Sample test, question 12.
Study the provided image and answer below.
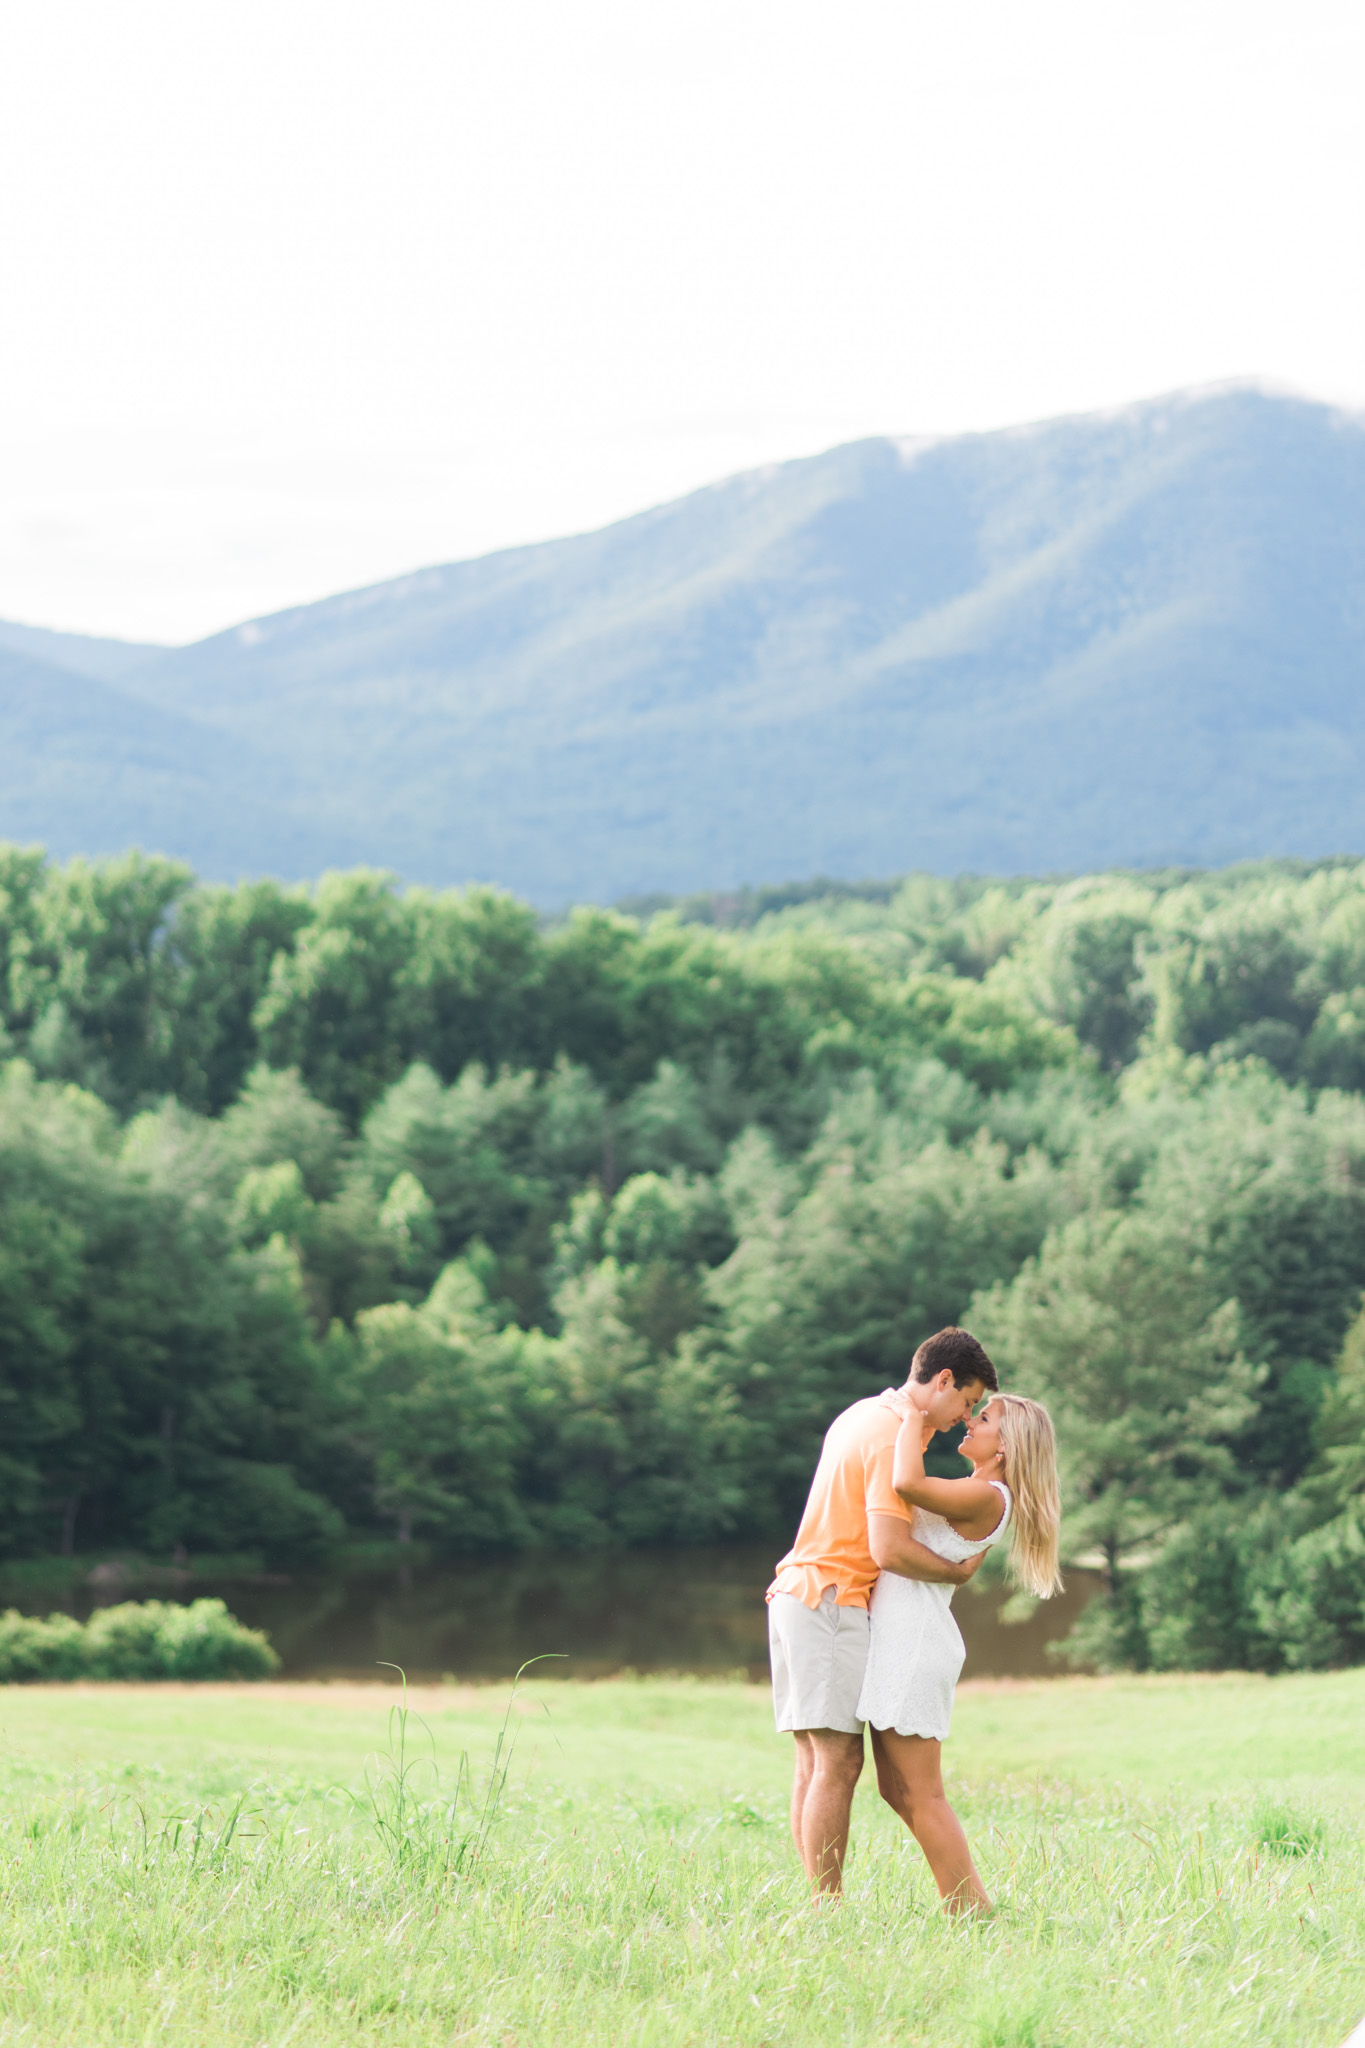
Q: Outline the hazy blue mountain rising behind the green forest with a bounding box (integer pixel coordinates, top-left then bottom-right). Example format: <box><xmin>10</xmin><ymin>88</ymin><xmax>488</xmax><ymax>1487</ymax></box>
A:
<box><xmin>0</xmin><ymin>391</ymin><xmax>1365</xmax><ymax>905</ymax></box>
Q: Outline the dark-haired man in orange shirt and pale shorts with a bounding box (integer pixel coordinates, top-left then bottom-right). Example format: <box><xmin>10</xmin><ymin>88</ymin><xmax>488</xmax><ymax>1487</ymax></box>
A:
<box><xmin>767</xmin><ymin>1329</ymin><xmax>999</xmax><ymax>1892</ymax></box>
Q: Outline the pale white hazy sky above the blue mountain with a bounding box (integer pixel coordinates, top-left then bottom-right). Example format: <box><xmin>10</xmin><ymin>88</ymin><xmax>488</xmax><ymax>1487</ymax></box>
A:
<box><xmin>0</xmin><ymin>0</ymin><xmax>1365</xmax><ymax>639</ymax></box>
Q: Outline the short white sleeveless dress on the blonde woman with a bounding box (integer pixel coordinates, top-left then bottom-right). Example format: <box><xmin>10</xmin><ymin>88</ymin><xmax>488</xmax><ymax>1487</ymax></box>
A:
<box><xmin>857</xmin><ymin>1479</ymin><xmax>1011</xmax><ymax>1743</ymax></box>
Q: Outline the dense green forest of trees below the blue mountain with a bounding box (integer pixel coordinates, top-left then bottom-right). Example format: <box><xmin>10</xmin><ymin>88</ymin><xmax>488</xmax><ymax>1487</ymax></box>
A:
<box><xmin>0</xmin><ymin>848</ymin><xmax>1365</xmax><ymax>1669</ymax></box>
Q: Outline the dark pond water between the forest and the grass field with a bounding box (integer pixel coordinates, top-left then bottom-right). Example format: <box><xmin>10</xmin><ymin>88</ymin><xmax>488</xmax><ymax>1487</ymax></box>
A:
<box><xmin>82</xmin><ymin>1542</ymin><xmax>1095</xmax><ymax>1679</ymax></box>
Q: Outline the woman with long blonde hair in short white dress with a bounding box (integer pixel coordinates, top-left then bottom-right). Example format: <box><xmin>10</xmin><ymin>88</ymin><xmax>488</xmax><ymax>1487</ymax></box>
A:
<box><xmin>857</xmin><ymin>1395</ymin><xmax>1062</xmax><ymax>1913</ymax></box>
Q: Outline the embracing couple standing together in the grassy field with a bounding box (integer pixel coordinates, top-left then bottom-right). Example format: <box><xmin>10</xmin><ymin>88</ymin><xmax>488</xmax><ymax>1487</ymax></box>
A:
<box><xmin>767</xmin><ymin>1329</ymin><xmax>1062</xmax><ymax>1913</ymax></box>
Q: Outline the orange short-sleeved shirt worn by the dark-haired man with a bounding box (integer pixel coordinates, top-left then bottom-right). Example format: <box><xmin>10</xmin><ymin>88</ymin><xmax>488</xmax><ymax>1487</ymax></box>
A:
<box><xmin>767</xmin><ymin>1386</ymin><xmax>915</xmax><ymax>1608</ymax></box>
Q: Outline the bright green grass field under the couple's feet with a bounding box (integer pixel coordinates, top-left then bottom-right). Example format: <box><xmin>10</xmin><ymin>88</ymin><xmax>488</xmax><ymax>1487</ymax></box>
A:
<box><xmin>0</xmin><ymin>1671</ymin><xmax>1365</xmax><ymax>2048</ymax></box>
